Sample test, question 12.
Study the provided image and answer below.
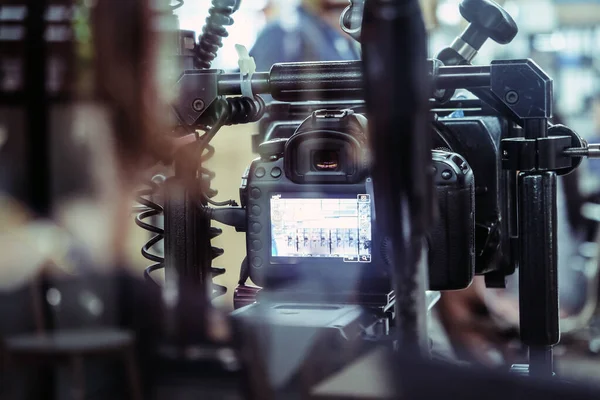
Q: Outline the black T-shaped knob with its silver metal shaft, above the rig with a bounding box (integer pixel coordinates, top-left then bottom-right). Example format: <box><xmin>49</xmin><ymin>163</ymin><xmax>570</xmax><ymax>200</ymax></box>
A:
<box><xmin>436</xmin><ymin>0</ymin><xmax>519</xmax><ymax>65</ymax></box>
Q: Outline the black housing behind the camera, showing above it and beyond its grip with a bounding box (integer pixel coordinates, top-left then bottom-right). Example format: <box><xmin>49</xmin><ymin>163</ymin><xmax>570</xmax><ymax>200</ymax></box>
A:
<box><xmin>253</xmin><ymin>101</ymin><xmax>519</xmax><ymax>287</ymax></box>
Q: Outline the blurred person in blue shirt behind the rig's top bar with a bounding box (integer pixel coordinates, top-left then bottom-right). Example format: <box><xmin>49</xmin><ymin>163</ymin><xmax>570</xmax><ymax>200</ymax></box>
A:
<box><xmin>250</xmin><ymin>0</ymin><xmax>360</xmax><ymax>71</ymax></box>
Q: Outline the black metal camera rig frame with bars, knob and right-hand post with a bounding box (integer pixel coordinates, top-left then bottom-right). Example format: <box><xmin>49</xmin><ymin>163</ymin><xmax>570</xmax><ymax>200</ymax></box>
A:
<box><xmin>138</xmin><ymin>0</ymin><xmax>597</xmax><ymax>382</ymax></box>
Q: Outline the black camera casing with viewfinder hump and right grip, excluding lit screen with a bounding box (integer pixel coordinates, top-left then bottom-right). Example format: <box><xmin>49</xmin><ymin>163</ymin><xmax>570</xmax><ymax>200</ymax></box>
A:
<box><xmin>240</xmin><ymin>104</ymin><xmax>486</xmax><ymax>298</ymax></box>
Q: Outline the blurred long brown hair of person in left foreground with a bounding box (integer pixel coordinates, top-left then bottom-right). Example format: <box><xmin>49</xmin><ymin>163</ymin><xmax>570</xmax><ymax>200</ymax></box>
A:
<box><xmin>92</xmin><ymin>0</ymin><xmax>169</xmax><ymax>183</ymax></box>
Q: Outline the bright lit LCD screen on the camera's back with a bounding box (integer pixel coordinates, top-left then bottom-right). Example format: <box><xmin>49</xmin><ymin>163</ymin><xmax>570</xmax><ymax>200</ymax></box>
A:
<box><xmin>271</xmin><ymin>194</ymin><xmax>371</xmax><ymax>262</ymax></box>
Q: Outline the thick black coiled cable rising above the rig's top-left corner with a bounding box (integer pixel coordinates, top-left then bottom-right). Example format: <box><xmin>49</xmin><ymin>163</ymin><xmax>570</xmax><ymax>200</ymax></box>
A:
<box><xmin>195</xmin><ymin>0</ymin><xmax>238</xmax><ymax>69</ymax></box>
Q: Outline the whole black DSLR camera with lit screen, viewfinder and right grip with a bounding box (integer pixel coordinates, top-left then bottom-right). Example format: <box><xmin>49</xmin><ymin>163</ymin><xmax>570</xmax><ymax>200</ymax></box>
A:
<box><xmin>241</xmin><ymin>104</ymin><xmax>476</xmax><ymax>305</ymax></box>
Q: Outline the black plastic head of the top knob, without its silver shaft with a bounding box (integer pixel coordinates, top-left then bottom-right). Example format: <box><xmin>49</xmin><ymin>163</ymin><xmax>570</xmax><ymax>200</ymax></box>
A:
<box><xmin>459</xmin><ymin>0</ymin><xmax>519</xmax><ymax>46</ymax></box>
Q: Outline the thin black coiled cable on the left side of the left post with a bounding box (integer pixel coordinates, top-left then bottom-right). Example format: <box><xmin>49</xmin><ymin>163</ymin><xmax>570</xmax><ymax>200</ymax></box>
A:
<box><xmin>135</xmin><ymin>181</ymin><xmax>165</xmax><ymax>283</ymax></box>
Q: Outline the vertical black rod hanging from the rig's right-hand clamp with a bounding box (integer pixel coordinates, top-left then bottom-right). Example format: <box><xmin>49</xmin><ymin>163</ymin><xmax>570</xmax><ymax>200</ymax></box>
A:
<box><xmin>518</xmin><ymin>172</ymin><xmax>560</xmax><ymax>377</ymax></box>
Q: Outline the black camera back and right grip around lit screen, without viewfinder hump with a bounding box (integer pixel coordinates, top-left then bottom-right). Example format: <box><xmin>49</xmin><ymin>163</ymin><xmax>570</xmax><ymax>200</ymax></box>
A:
<box><xmin>241</xmin><ymin>145</ymin><xmax>475</xmax><ymax>294</ymax></box>
